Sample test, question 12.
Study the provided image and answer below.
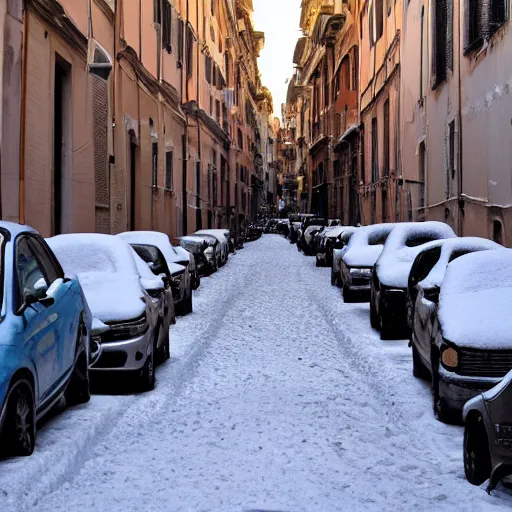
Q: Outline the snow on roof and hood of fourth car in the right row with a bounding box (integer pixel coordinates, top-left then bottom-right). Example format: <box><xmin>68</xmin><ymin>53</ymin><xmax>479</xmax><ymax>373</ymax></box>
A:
<box><xmin>343</xmin><ymin>224</ymin><xmax>396</xmax><ymax>267</ymax></box>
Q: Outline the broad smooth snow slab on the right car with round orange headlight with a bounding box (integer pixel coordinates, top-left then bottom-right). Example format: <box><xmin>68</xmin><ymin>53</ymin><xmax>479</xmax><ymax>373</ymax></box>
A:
<box><xmin>438</xmin><ymin>249</ymin><xmax>512</xmax><ymax>349</ymax></box>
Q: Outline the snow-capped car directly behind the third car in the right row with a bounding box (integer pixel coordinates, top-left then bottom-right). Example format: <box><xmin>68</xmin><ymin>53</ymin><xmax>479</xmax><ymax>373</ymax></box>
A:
<box><xmin>339</xmin><ymin>224</ymin><xmax>396</xmax><ymax>302</ymax></box>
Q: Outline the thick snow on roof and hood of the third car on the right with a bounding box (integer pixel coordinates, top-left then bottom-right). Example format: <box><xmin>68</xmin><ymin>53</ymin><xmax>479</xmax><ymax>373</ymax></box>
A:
<box><xmin>377</xmin><ymin>221</ymin><xmax>457</xmax><ymax>288</ymax></box>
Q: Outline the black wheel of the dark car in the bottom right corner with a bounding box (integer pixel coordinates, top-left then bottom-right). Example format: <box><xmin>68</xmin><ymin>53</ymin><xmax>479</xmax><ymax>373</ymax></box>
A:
<box><xmin>464</xmin><ymin>415</ymin><xmax>492</xmax><ymax>485</ymax></box>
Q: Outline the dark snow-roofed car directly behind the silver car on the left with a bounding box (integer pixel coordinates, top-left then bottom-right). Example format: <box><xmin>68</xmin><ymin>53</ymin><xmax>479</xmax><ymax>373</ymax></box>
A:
<box><xmin>117</xmin><ymin>231</ymin><xmax>193</xmax><ymax>315</ymax></box>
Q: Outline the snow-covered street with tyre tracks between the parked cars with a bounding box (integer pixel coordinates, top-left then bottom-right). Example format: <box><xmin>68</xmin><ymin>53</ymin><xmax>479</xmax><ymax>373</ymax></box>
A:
<box><xmin>0</xmin><ymin>235</ymin><xmax>512</xmax><ymax>512</ymax></box>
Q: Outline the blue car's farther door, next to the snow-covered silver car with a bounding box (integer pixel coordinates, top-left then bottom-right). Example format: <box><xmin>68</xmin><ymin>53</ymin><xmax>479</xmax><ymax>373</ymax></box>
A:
<box><xmin>30</xmin><ymin>235</ymin><xmax>78</xmax><ymax>379</ymax></box>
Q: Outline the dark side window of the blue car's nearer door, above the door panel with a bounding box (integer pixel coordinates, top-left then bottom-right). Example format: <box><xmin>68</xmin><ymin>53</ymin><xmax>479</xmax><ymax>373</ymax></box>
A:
<box><xmin>15</xmin><ymin>236</ymin><xmax>50</xmax><ymax>309</ymax></box>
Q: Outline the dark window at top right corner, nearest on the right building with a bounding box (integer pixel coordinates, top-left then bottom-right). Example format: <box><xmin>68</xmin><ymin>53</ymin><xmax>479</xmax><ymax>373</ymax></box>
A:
<box><xmin>465</xmin><ymin>0</ymin><xmax>509</xmax><ymax>53</ymax></box>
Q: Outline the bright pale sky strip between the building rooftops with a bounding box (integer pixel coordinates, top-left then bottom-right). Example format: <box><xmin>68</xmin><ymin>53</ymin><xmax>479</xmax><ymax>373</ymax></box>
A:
<box><xmin>253</xmin><ymin>0</ymin><xmax>301</xmax><ymax>118</ymax></box>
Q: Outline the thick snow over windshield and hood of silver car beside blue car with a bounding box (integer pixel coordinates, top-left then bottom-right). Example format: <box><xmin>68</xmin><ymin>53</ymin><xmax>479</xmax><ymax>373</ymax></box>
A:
<box><xmin>46</xmin><ymin>233</ymin><xmax>146</xmax><ymax>322</ymax></box>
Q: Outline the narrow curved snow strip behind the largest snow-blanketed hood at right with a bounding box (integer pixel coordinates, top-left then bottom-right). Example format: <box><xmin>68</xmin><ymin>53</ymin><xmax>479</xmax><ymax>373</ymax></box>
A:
<box><xmin>419</xmin><ymin>236</ymin><xmax>503</xmax><ymax>289</ymax></box>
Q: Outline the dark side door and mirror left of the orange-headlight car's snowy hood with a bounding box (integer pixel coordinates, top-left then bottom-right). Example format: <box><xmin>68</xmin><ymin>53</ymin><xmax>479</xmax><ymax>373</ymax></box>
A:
<box><xmin>409</xmin><ymin>247</ymin><xmax>441</xmax><ymax>361</ymax></box>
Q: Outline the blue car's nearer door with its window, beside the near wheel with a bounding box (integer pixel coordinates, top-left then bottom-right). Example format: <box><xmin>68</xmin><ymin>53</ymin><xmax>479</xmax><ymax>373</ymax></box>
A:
<box><xmin>14</xmin><ymin>235</ymin><xmax>60</xmax><ymax>405</ymax></box>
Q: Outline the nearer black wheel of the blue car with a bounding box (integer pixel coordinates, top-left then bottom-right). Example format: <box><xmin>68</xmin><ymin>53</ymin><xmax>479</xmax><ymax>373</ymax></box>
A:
<box><xmin>3</xmin><ymin>380</ymin><xmax>36</xmax><ymax>457</ymax></box>
